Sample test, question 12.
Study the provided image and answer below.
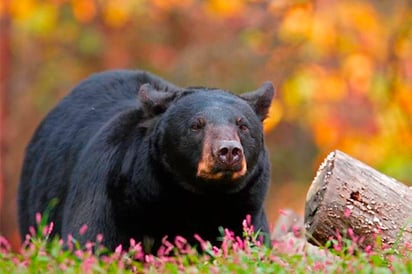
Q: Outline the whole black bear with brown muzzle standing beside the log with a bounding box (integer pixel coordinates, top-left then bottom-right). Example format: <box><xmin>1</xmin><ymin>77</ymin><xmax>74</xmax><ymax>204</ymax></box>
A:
<box><xmin>18</xmin><ymin>70</ymin><xmax>274</xmax><ymax>251</ymax></box>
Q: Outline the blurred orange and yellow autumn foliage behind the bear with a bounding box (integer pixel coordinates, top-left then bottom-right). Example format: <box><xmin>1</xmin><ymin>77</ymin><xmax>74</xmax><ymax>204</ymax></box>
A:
<box><xmin>0</xmin><ymin>0</ymin><xmax>412</xmax><ymax>249</ymax></box>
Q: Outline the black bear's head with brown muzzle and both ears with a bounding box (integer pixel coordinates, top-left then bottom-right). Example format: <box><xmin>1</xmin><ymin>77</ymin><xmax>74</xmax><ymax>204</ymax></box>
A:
<box><xmin>139</xmin><ymin>82</ymin><xmax>274</xmax><ymax>193</ymax></box>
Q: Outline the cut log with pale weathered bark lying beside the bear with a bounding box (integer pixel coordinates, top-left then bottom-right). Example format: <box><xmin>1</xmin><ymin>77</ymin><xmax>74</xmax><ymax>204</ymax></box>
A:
<box><xmin>304</xmin><ymin>151</ymin><xmax>412</xmax><ymax>248</ymax></box>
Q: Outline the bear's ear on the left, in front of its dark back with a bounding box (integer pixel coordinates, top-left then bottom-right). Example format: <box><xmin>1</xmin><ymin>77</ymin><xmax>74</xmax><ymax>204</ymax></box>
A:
<box><xmin>137</xmin><ymin>83</ymin><xmax>178</xmax><ymax>116</ymax></box>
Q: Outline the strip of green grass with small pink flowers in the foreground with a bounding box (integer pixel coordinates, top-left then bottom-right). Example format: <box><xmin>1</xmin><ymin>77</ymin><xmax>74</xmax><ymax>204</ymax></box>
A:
<box><xmin>0</xmin><ymin>216</ymin><xmax>412</xmax><ymax>274</ymax></box>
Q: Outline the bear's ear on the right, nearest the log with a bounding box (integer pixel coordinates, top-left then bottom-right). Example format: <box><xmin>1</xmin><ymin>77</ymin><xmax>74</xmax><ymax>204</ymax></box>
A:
<box><xmin>240</xmin><ymin>81</ymin><xmax>275</xmax><ymax>121</ymax></box>
